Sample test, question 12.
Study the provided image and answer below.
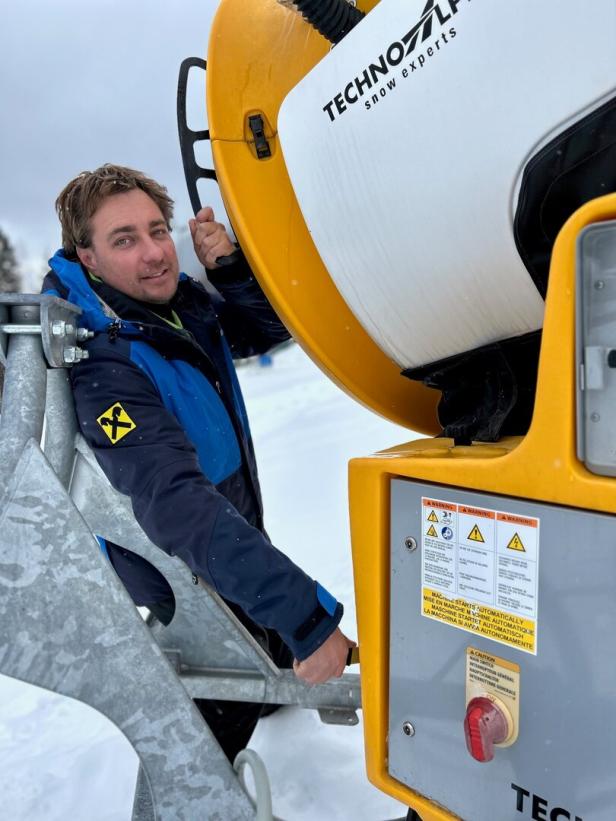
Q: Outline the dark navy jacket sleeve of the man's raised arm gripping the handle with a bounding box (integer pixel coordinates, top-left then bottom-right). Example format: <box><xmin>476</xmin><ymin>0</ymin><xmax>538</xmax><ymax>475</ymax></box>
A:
<box><xmin>207</xmin><ymin>250</ymin><xmax>290</xmax><ymax>359</ymax></box>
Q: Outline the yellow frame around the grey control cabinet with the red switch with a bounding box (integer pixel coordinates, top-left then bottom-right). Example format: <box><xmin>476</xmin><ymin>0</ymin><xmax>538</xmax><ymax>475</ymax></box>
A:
<box><xmin>349</xmin><ymin>195</ymin><xmax>616</xmax><ymax>821</ymax></box>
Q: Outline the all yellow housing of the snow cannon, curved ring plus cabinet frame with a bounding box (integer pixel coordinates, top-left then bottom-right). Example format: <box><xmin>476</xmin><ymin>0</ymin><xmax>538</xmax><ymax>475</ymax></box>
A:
<box><xmin>207</xmin><ymin>0</ymin><xmax>616</xmax><ymax>821</ymax></box>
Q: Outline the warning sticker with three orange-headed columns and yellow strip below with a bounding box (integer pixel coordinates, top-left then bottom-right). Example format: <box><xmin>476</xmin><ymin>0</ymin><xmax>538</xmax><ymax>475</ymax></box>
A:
<box><xmin>421</xmin><ymin>497</ymin><xmax>539</xmax><ymax>655</ymax></box>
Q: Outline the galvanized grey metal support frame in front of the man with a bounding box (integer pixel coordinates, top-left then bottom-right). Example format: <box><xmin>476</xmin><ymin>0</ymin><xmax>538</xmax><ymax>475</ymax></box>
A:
<box><xmin>0</xmin><ymin>294</ymin><xmax>361</xmax><ymax>821</ymax></box>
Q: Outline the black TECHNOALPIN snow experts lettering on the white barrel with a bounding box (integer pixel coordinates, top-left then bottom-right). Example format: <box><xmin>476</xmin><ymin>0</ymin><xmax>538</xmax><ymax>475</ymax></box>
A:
<box><xmin>323</xmin><ymin>0</ymin><xmax>471</xmax><ymax>122</ymax></box>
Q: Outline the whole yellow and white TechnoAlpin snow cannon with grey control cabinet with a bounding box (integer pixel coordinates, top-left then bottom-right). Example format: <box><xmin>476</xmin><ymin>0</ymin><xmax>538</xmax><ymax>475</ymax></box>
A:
<box><xmin>184</xmin><ymin>0</ymin><xmax>616</xmax><ymax>821</ymax></box>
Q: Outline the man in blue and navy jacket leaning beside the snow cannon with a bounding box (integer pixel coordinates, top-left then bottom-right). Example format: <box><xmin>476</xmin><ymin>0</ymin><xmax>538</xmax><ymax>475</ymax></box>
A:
<box><xmin>43</xmin><ymin>165</ymin><xmax>353</xmax><ymax>760</ymax></box>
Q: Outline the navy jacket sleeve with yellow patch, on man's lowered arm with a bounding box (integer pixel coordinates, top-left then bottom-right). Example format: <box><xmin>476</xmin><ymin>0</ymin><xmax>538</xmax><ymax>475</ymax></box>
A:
<box><xmin>71</xmin><ymin>339</ymin><xmax>342</xmax><ymax>660</ymax></box>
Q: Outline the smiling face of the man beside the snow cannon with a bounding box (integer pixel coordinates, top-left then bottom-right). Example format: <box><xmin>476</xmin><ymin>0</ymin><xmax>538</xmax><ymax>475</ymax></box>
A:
<box><xmin>77</xmin><ymin>188</ymin><xmax>179</xmax><ymax>304</ymax></box>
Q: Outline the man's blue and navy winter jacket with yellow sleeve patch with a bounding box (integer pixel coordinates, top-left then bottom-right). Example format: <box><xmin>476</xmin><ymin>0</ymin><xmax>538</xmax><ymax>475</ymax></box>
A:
<box><xmin>43</xmin><ymin>251</ymin><xmax>342</xmax><ymax>660</ymax></box>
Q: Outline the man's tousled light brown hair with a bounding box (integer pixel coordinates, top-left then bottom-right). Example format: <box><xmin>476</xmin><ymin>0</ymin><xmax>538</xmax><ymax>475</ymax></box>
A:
<box><xmin>56</xmin><ymin>163</ymin><xmax>173</xmax><ymax>259</ymax></box>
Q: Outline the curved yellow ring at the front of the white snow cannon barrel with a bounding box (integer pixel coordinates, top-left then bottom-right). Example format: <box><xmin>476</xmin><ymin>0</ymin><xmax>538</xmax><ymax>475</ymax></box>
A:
<box><xmin>207</xmin><ymin>0</ymin><xmax>439</xmax><ymax>433</ymax></box>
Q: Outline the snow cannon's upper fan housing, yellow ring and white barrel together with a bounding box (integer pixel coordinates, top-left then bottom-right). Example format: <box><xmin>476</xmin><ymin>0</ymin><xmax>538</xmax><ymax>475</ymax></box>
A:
<box><xmin>208</xmin><ymin>0</ymin><xmax>616</xmax><ymax>441</ymax></box>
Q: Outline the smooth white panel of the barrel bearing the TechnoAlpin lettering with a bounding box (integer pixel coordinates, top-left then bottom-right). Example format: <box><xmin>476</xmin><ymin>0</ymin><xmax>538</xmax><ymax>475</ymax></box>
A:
<box><xmin>278</xmin><ymin>0</ymin><xmax>616</xmax><ymax>367</ymax></box>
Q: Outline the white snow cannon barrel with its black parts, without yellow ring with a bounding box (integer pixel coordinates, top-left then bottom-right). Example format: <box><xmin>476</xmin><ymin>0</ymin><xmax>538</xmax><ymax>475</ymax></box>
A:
<box><xmin>278</xmin><ymin>0</ymin><xmax>616</xmax><ymax>443</ymax></box>
